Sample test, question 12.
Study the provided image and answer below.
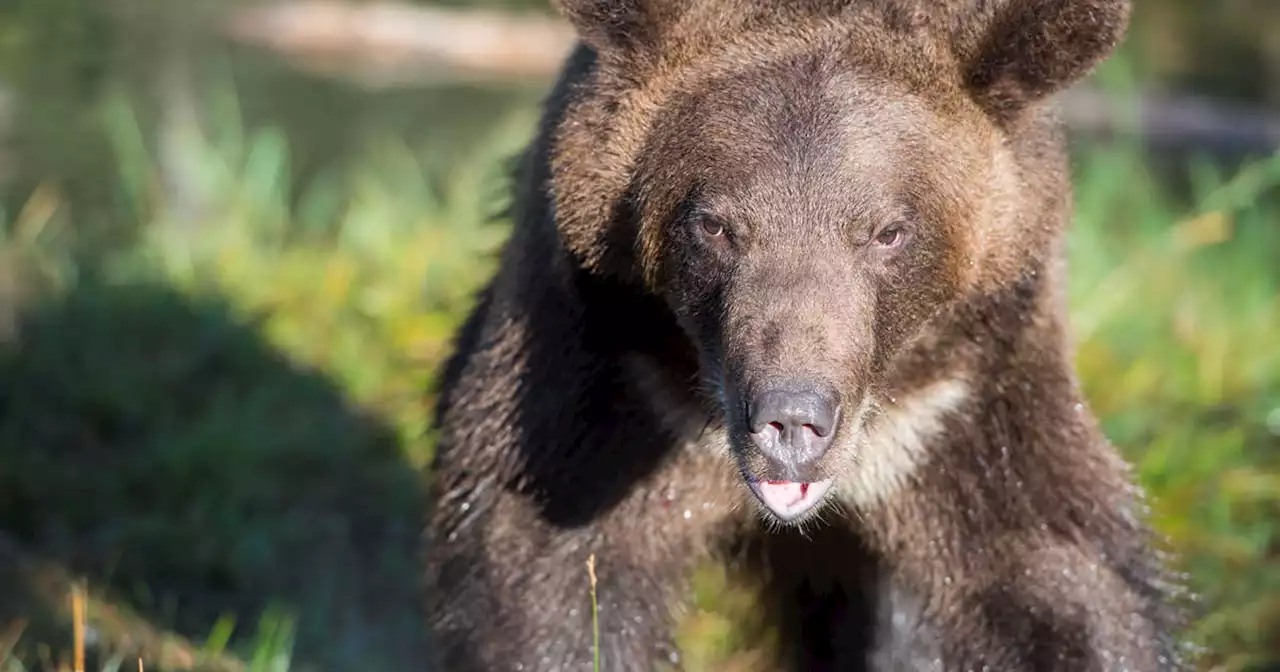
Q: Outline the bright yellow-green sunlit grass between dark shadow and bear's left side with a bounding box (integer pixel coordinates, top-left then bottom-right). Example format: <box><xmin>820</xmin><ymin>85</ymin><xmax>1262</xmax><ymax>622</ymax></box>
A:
<box><xmin>98</xmin><ymin>81</ymin><xmax>532</xmax><ymax>466</ymax></box>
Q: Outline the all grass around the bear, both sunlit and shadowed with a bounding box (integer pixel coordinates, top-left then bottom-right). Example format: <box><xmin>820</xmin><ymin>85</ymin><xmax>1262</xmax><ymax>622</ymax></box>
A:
<box><xmin>0</xmin><ymin>62</ymin><xmax>1280</xmax><ymax>672</ymax></box>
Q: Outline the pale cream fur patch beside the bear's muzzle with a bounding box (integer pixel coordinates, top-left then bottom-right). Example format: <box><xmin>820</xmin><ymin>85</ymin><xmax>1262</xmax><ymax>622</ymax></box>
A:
<box><xmin>837</xmin><ymin>374</ymin><xmax>972</xmax><ymax>511</ymax></box>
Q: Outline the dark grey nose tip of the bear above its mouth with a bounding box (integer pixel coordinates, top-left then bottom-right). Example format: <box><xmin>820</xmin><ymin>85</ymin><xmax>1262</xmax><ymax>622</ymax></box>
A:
<box><xmin>750</xmin><ymin>387</ymin><xmax>840</xmax><ymax>468</ymax></box>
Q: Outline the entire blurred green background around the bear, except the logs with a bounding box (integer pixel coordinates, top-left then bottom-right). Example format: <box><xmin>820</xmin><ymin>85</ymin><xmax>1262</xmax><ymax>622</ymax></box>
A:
<box><xmin>0</xmin><ymin>0</ymin><xmax>1280</xmax><ymax>672</ymax></box>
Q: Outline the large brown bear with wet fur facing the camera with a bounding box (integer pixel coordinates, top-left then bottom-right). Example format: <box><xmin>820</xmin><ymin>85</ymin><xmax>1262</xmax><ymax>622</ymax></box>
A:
<box><xmin>426</xmin><ymin>0</ymin><xmax>1184</xmax><ymax>672</ymax></box>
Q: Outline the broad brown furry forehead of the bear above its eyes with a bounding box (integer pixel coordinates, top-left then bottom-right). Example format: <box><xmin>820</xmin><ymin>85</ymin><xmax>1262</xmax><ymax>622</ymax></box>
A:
<box><xmin>637</xmin><ymin>54</ymin><xmax>992</xmax><ymax>230</ymax></box>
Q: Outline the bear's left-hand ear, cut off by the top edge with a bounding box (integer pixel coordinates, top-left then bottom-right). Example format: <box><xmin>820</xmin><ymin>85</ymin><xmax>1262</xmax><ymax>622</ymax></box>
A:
<box><xmin>552</xmin><ymin>0</ymin><xmax>682</xmax><ymax>51</ymax></box>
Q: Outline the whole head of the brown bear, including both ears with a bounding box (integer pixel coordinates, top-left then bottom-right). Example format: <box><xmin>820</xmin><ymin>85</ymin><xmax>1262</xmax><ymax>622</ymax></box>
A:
<box><xmin>552</xmin><ymin>0</ymin><xmax>1129</xmax><ymax>524</ymax></box>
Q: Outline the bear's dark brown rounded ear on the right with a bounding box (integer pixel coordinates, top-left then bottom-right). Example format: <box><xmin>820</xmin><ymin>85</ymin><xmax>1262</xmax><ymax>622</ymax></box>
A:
<box><xmin>952</xmin><ymin>0</ymin><xmax>1132</xmax><ymax>122</ymax></box>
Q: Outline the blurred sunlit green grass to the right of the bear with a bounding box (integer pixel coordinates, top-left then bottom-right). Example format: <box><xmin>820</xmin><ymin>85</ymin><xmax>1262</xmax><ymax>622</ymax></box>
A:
<box><xmin>1071</xmin><ymin>144</ymin><xmax>1280</xmax><ymax>669</ymax></box>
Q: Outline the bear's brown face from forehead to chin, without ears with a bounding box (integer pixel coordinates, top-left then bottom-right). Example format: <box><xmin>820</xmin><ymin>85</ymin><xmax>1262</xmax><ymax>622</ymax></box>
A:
<box><xmin>636</xmin><ymin>54</ymin><xmax>997</xmax><ymax>521</ymax></box>
